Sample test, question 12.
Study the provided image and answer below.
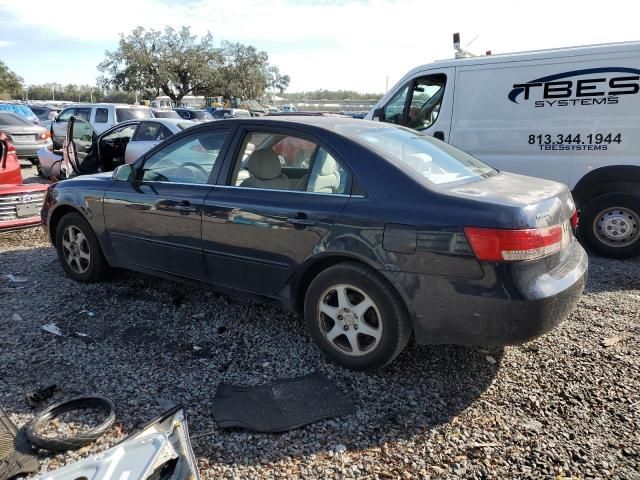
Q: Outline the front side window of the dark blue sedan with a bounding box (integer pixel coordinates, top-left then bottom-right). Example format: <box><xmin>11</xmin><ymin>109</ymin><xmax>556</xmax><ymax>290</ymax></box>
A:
<box><xmin>142</xmin><ymin>130</ymin><xmax>229</xmax><ymax>184</ymax></box>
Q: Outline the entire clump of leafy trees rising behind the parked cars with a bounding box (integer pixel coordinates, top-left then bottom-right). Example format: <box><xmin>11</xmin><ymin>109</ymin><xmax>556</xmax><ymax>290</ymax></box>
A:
<box><xmin>98</xmin><ymin>27</ymin><xmax>290</xmax><ymax>103</ymax></box>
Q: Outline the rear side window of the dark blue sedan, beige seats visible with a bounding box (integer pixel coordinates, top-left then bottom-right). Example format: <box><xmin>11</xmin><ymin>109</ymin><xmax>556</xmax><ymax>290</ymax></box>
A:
<box><xmin>230</xmin><ymin>132</ymin><xmax>348</xmax><ymax>193</ymax></box>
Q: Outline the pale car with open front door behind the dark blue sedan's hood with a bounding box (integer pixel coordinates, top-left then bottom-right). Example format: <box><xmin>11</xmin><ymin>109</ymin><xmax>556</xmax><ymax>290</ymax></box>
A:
<box><xmin>38</xmin><ymin>117</ymin><xmax>195</xmax><ymax>178</ymax></box>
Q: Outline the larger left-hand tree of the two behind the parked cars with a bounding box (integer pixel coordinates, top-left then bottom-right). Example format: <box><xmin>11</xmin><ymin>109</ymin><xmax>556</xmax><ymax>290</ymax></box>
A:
<box><xmin>98</xmin><ymin>27</ymin><xmax>222</xmax><ymax>103</ymax></box>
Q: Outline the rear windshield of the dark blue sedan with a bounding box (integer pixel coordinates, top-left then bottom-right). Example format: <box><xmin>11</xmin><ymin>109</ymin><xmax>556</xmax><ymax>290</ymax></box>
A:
<box><xmin>336</xmin><ymin>125</ymin><xmax>496</xmax><ymax>185</ymax></box>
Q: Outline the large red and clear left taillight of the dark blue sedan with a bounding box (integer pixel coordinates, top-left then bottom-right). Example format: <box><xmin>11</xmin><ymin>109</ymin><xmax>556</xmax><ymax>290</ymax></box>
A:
<box><xmin>464</xmin><ymin>225</ymin><xmax>562</xmax><ymax>262</ymax></box>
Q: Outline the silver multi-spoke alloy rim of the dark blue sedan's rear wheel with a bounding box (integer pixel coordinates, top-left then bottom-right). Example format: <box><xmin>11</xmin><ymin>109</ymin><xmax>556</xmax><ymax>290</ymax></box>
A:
<box><xmin>317</xmin><ymin>284</ymin><xmax>382</xmax><ymax>357</ymax></box>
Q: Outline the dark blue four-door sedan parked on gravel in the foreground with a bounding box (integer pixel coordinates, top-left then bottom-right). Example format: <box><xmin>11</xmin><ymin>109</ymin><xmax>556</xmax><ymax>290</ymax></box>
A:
<box><xmin>42</xmin><ymin>116</ymin><xmax>587</xmax><ymax>369</ymax></box>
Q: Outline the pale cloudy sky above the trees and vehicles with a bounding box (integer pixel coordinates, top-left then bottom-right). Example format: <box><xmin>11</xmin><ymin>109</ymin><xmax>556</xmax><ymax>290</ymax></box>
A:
<box><xmin>0</xmin><ymin>0</ymin><xmax>640</xmax><ymax>93</ymax></box>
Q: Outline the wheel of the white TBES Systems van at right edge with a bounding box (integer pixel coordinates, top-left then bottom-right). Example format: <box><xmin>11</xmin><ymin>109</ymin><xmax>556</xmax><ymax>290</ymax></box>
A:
<box><xmin>578</xmin><ymin>193</ymin><xmax>640</xmax><ymax>259</ymax></box>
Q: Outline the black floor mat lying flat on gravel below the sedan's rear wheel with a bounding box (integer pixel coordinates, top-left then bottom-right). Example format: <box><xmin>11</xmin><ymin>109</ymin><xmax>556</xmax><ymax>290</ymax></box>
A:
<box><xmin>213</xmin><ymin>373</ymin><xmax>355</xmax><ymax>432</ymax></box>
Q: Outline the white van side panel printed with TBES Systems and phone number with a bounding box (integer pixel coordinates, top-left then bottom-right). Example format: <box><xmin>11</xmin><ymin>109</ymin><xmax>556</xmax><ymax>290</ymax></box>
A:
<box><xmin>449</xmin><ymin>49</ymin><xmax>640</xmax><ymax>188</ymax></box>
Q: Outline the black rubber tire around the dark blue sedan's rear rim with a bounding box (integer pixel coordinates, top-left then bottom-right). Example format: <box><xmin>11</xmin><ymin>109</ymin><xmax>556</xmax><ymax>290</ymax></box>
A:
<box><xmin>304</xmin><ymin>262</ymin><xmax>412</xmax><ymax>370</ymax></box>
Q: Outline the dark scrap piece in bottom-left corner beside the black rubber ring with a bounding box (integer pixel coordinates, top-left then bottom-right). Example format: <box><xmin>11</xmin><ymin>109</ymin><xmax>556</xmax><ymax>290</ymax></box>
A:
<box><xmin>0</xmin><ymin>407</ymin><xmax>39</xmax><ymax>480</ymax></box>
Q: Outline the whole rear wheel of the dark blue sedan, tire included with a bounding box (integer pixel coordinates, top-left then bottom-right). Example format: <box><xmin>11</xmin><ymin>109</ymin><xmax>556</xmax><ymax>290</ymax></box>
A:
<box><xmin>304</xmin><ymin>262</ymin><xmax>411</xmax><ymax>370</ymax></box>
